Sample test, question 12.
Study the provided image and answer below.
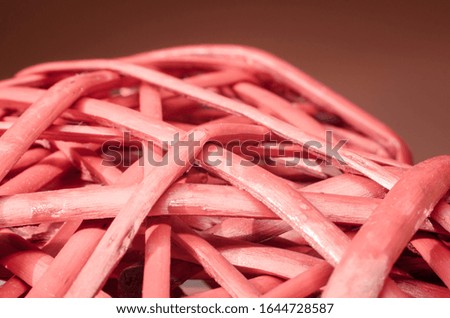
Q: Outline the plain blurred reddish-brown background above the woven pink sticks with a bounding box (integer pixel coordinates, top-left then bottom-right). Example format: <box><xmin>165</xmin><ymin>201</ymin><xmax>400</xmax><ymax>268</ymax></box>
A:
<box><xmin>0</xmin><ymin>0</ymin><xmax>450</xmax><ymax>161</ymax></box>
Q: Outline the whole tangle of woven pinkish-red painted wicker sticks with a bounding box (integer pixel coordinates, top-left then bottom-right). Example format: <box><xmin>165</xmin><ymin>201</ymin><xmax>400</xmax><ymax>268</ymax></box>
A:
<box><xmin>0</xmin><ymin>45</ymin><xmax>450</xmax><ymax>297</ymax></box>
